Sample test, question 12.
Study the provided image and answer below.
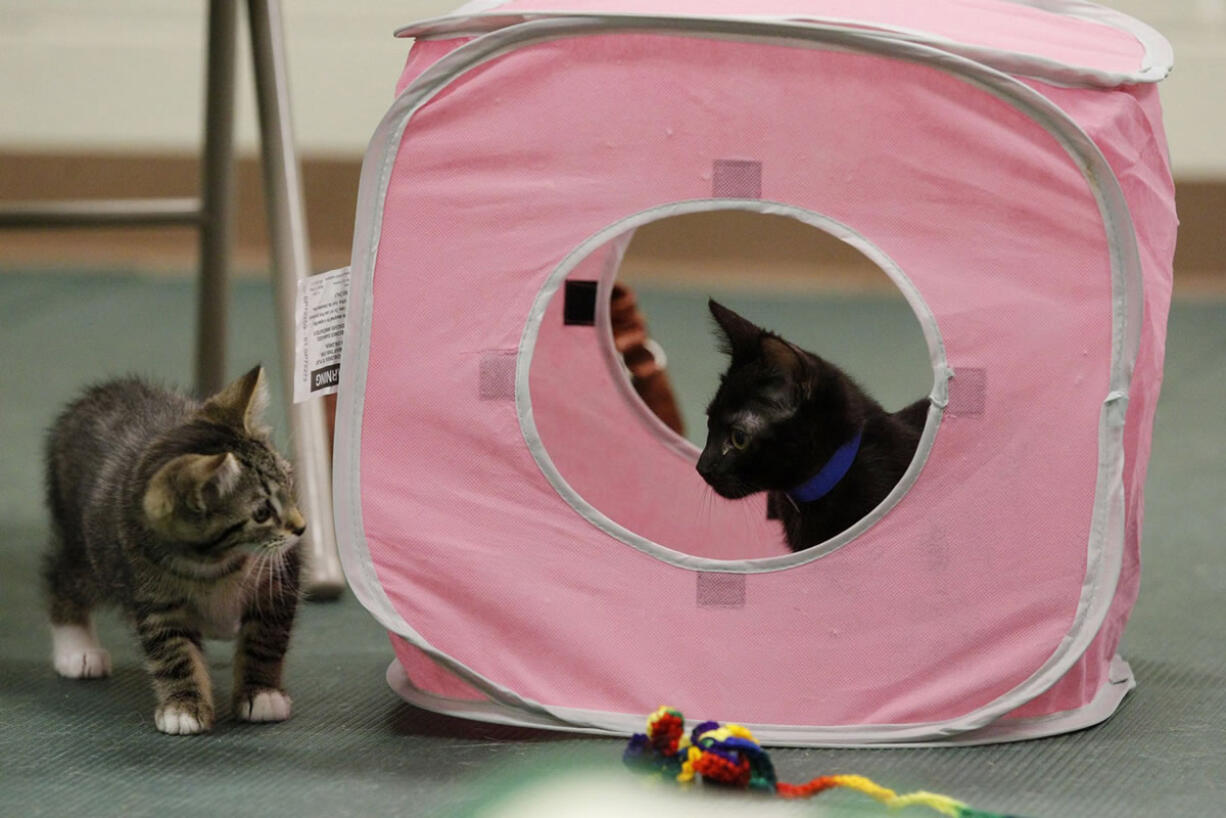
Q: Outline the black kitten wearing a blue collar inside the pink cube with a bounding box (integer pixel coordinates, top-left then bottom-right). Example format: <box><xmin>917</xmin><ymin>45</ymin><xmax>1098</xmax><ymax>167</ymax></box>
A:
<box><xmin>698</xmin><ymin>300</ymin><xmax>928</xmax><ymax>551</ymax></box>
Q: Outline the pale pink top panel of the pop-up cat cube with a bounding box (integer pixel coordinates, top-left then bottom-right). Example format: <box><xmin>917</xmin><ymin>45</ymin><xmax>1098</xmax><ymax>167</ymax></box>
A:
<box><xmin>493</xmin><ymin>0</ymin><xmax>1145</xmax><ymax>71</ymax></box>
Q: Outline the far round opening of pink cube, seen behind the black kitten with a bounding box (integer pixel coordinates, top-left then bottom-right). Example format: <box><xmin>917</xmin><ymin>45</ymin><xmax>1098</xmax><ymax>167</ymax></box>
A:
<box><xmin>609</xmin><ymin>211</ymin><xmax>933</xmax><ymax>449</ymax></box>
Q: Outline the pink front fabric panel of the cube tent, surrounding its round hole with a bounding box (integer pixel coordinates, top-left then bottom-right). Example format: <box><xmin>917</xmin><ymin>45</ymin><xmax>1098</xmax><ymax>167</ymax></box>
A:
<box><xmin>362</xmin><ymin>36</ymin><xmax>1127</xmax><ymax>725</ymax></box>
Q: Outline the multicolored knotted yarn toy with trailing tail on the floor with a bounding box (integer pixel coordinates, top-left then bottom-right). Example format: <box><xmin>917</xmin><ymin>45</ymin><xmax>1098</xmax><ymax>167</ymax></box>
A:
<box><xmin>622</xmin><ymin>708</ymin><xmax>1014</xmax><ymax>818</ymax></box>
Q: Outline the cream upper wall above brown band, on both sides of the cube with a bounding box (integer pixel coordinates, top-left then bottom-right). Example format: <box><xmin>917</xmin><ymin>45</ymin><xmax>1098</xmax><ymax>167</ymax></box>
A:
<box><xmin>0</xmin><ymin>0</ymin><xmax>1226</xmax><ymax>179</ymax></box>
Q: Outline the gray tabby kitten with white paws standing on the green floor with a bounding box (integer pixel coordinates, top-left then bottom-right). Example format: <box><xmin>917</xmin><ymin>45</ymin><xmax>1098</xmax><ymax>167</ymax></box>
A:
<box><xmin>44</xmin><ymin>367</ymin><xmax>305</xmax><ymax>733</ymax></box>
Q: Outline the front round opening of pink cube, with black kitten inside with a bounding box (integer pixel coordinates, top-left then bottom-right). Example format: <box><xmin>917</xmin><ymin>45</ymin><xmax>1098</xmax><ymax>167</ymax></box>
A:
<box><xmin>521</xmin><ymin>206</ymin><xmax>939</xmax><ymax>564</ymax></box>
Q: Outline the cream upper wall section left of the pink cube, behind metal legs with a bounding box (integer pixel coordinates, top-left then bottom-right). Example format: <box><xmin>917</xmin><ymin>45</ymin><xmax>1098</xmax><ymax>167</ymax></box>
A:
<box><xmin>0</xmin><ymin>0</ymin><xmax>459</xmax><ymax>157</ymax></box>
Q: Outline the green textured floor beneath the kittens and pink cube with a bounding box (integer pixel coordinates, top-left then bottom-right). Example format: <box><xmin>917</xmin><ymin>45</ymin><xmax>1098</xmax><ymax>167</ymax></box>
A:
<box><xmin>0</xmin><ymin>272</ymin><xmax>1226</xmax><ymax>818</ymax></box>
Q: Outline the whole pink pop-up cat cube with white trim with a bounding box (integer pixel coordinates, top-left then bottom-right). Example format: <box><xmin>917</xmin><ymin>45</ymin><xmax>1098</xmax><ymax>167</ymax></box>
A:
<box><xmin>335</xmin><ymin>0</ymin><xmax>1176</xmax><ymax>744</ymax></box>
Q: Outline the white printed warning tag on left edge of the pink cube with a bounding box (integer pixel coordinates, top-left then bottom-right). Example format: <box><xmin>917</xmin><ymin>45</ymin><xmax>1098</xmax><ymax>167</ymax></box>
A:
<box><xmin>294</xmin><ymin>267</ymin><xmax>349</xmax><ymax>403</ymax></box>
